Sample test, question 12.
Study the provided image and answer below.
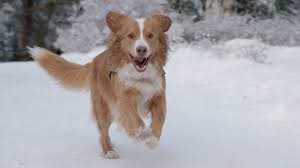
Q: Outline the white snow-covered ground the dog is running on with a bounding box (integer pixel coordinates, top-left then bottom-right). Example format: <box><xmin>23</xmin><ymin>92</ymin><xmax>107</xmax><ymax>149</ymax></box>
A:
<box><xmin>0</xmin><ymin>40</ymin><xmax>300</xmax><ymax>168</ymax></box>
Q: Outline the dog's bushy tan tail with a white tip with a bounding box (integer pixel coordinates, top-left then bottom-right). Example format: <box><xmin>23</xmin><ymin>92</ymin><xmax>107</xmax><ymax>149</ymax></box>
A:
<box><xmin>27</xmin><ymin>47</ymin><xmax>90</xmax><ymax>90</ymax></box>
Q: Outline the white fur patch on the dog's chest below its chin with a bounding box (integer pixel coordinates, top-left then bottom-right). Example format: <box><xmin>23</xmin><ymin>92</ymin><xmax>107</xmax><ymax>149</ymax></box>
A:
<box><xmin>118</xmin><ymin>64</ymin><xmax>162</xmax><ymax>114</ymax></box>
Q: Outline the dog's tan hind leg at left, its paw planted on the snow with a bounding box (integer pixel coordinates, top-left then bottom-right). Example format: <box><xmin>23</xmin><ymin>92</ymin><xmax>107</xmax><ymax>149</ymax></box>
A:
<box><xmin>93</xmin><ymin>96</ymin><xmax>119</xmax><ymax>159</ymax></box>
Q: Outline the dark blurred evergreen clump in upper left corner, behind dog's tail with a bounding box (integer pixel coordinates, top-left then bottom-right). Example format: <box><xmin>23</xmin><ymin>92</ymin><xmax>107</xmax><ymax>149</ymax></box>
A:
<box><xmin>0</xmin><ymin>0</ymin><xmax>79</xmax><ymax>61</ymax></box>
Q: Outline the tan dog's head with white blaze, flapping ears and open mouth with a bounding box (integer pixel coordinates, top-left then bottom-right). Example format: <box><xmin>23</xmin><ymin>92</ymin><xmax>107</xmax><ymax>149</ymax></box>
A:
<box><xmin>106</xmin><ymin>12</ymin><xmax>172</xmax><ymax>72</ymax></box>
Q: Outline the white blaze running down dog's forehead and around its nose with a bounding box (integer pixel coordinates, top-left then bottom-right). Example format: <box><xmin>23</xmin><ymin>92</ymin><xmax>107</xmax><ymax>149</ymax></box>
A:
<box><xmin>130</xmin><ymin>18</ymin><xmax>151</xmax><ymax>58</ymax></box>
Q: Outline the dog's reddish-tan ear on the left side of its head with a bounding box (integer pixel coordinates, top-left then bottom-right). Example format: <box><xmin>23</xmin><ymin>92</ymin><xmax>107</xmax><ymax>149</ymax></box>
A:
<box><xmin>106</xmin><ymin>11</ymin><xmax>127</xmax><ymax>33</ymax></box>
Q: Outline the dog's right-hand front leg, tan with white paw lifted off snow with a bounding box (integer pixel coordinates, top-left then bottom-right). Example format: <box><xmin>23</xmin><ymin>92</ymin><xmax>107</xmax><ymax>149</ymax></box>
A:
<box><xmin>146</xmin><ymin>92</ymin><xmax>166</xmax><ymax>149</ymax></box>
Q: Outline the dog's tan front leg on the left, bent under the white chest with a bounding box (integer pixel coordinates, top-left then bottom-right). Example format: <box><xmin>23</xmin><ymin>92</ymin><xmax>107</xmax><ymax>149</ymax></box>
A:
<box><xmin>118</xmin><ymin>89</ymin><xmax>145</xmax><ymax>138</ymax></box>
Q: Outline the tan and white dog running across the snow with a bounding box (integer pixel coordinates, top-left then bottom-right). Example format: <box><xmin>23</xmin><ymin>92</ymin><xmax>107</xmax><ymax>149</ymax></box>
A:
<box><xmin>28</xmin><ymin>12</ymin><xmax>172</xmax><ymax>159</ymax></box>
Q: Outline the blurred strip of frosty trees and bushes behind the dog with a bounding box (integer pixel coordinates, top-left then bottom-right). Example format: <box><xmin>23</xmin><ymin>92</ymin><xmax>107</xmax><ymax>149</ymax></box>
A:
<box><xmin>0</xmin><ymin>0</ymin><xmax>300</xmax><ymax>62</ymax></box>
